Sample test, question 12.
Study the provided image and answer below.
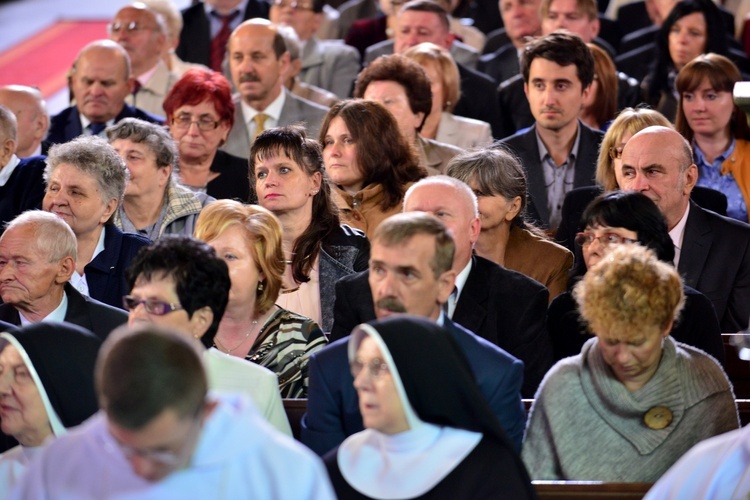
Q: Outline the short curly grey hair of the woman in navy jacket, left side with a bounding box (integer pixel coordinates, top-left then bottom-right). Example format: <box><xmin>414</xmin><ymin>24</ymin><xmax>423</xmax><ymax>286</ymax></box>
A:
<box><xmin>44</xmin><ymin>135</ymin><xmax>129</xmax><ymax>204</ymax></box>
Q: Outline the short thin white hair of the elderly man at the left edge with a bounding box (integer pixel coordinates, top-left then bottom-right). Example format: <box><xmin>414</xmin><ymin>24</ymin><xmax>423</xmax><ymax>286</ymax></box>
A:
<box><xmin>0</xmin><ymin>210</ymin><xmax>78</xmax><ymax>262</ymax></box>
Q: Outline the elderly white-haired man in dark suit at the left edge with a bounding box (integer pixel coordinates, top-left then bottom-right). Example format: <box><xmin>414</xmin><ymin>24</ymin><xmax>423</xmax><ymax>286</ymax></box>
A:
<box><xmin>0</xmin><ymin>210</ymin><xmax>128</xmax><ymax>339</ymax></box>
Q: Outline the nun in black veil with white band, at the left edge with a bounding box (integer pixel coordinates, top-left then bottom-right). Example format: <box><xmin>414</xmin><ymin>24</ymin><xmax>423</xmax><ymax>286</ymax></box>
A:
<box><xmin>0</xmin><ymin>323</ymin><xmax>101</xmax><ymax>498</ymax></box>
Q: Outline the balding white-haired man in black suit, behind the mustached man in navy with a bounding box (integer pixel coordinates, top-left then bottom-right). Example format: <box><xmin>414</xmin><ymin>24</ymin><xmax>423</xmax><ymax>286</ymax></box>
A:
<box><xmin>331</xmin><ymin>175</ymin><xmax>552</xmax><ymax>398</ymax></box>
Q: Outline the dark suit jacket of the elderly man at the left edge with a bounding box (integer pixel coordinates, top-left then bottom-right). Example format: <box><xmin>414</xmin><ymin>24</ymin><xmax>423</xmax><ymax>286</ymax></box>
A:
<box><xmin>0</xmin><ymin>283</ymin><xmax>128</xmax><ymax>340</ymax></box>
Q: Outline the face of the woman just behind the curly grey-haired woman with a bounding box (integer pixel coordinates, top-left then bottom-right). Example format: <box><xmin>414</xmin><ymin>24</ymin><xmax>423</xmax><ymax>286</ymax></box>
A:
<box><xmin>112</xmin><ymin>139</ymin><xmax>172</xmax><ymax>197</ymax></box>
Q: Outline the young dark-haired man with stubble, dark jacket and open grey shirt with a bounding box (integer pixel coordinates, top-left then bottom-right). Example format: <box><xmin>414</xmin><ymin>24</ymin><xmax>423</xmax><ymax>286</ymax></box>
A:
<box><xmin>503</xmin><ymin>32</ymin><xmax>604</xmax><ymax>231</ymax></box>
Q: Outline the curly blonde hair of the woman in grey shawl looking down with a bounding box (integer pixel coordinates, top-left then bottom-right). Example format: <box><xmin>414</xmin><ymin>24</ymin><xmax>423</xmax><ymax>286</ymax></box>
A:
<box><xmin>573</xmin><ymin>244</ymin><xmax>685</xmax><ymax>341</ymax></box>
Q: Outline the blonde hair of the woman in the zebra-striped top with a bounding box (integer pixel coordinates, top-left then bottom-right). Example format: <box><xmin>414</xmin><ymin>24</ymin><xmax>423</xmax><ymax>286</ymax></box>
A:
<box><xmin>195</xmin><ymin>200</ymin><xmax>285</xmax><ymax>314</ymax></box>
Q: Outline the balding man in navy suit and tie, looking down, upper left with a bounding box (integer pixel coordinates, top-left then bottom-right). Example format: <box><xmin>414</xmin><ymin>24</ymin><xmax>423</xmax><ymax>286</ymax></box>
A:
<box><xmin>42</xmin><ymin>40</ymin><xmax>164</xmax><ymax>154</ymax></box>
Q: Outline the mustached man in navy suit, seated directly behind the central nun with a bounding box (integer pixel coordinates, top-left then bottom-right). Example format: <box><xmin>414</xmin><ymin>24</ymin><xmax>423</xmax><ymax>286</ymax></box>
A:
<box><xmin>301</xmin><ymin>213</ymin><xmax>525</xmax><ymax>455</ymax></box>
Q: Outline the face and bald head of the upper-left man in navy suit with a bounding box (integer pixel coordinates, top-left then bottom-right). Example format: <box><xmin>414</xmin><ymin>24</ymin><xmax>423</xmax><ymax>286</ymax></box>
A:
<box><xmin>71</xmin><ymin>49</ymin><xmax>130</xmax><ymax>123</ymax></box>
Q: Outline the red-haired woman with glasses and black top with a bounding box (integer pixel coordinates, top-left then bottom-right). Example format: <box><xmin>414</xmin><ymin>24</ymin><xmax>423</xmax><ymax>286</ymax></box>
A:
<box><xmin>164</xmin><ymin>69</ymin><xmax>250</xmax><ymax>202</ymax></box>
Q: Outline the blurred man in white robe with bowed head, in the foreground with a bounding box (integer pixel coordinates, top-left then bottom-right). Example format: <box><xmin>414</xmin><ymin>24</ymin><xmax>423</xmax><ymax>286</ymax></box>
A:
<box><xmin>11</xmin><ymin>325</ymin><xmax>335</xmax><ymax>500</ymax></box>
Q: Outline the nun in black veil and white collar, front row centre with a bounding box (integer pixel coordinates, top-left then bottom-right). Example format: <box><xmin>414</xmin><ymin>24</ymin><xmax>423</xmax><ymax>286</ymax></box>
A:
<box><xmin>324</xmin><ymin>315</ymin><xmax>536</xmax><ymax>500</ymax></box>
